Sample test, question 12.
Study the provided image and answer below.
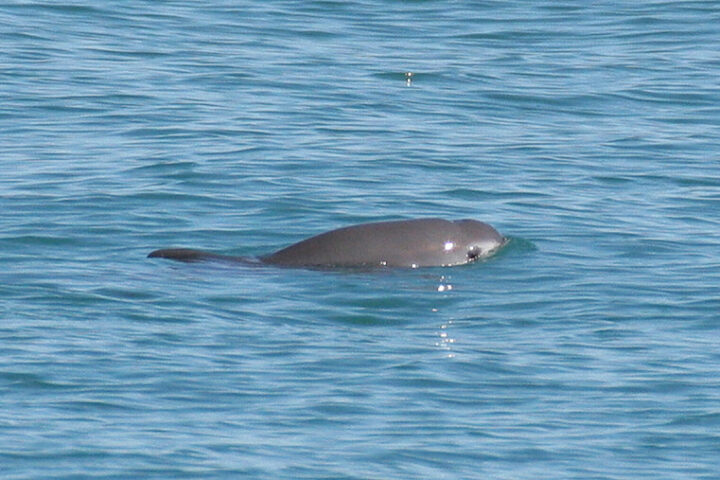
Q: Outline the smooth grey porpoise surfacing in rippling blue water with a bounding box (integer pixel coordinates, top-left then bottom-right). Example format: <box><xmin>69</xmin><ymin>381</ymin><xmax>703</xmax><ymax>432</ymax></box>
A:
<box><xmin>148</xmin><ymin>218</ymin><xmax>506</xmax><ymax>268</ymax></box>
